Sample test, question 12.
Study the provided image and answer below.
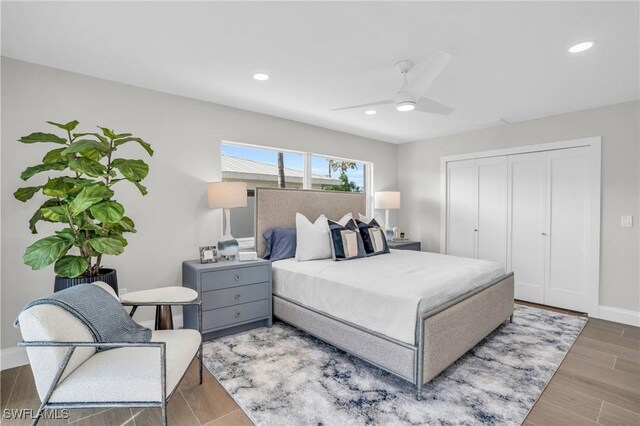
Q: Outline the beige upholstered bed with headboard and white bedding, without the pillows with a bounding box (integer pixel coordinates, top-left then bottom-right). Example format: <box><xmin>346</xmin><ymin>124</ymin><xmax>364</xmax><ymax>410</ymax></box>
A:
<box><xmin>256</xmin><ymin>188</ymin><xmax>514</xmax><ymax>399</ymax></box>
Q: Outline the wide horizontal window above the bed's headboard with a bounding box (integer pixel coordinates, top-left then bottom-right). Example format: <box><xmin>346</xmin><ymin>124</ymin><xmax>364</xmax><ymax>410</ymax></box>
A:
<box><xmin>221</xmin><ymin>142</ymin><xmax>372</xmax><ymax>239</ymax></box>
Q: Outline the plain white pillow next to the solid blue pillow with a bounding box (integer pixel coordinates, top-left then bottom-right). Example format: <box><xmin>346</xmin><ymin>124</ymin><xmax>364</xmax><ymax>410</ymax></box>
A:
<box><xmin>296</xmin><ymin>213</ymin><xmax>331</xmax><ymax>261</ymax></box>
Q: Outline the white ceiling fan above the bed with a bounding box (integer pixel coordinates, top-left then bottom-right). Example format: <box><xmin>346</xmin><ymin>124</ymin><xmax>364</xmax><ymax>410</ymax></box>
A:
<box><xmin>331</xmin><ymin>52</ymin><xmax>453</xmax><ymax>115</ymax></box>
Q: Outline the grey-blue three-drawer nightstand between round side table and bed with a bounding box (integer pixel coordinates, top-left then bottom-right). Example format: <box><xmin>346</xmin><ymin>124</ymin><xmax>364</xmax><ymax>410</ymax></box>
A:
<box><xmin>182</xmin><ymin>259</ymin><xmax>273</xmax><ymax>340</ymax></box>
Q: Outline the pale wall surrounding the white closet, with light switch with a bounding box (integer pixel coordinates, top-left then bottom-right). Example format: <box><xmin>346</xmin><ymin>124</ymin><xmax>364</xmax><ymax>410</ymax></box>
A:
<box><xmin>398</xmin><ymin>101</ymin><xmax>640</xmax><ymax>312</ymax></box>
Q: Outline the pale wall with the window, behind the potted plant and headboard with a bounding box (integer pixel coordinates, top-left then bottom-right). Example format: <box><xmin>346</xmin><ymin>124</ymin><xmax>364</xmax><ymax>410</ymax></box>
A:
<box><xmin>1</xmin><ymin>58</ymin><xmax>397</xmax><ymax>348</ymax></box>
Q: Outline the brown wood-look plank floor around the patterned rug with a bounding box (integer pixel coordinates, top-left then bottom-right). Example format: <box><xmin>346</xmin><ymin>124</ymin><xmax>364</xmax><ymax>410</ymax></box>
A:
<box><xmin>0</xmin><ymin>305</ymin><xmax>640</xmax><ymax>426</ymax></box>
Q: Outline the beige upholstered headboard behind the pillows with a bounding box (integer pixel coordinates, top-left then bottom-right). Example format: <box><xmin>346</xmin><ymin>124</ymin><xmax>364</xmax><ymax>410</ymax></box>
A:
<box><xmin>256</xmin><ymin>188</ymin><xmax>367</xmax><ymax>257</ymax></box>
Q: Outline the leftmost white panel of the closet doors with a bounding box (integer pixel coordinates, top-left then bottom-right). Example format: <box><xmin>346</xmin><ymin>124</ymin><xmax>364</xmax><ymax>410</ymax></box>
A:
<box><xmin>446</xmin><ymin>160</ymin><xmax>477</xmax><ymax>257</ymax></box>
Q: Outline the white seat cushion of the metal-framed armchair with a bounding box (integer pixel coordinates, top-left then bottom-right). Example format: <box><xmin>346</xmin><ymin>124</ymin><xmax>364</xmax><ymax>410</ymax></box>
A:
<box><xmin>50</xmin><ymin>329</ymin><xmax>201</xmax><ymax>402</ymax></box>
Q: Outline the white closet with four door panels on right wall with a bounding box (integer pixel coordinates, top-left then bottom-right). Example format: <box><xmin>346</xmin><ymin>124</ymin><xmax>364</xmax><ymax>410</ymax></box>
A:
<box><xmin>441</xmin><ymin>138</ymin><xmax>600</xmax><ymax>313</ymax></box>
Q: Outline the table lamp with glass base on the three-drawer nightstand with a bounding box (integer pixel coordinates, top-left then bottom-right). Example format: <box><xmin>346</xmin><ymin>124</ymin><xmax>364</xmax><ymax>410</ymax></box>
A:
<box><xmin>208</xmin><ymin>182</ymin><xmax>247</xmax><ymax>259</ymax></box>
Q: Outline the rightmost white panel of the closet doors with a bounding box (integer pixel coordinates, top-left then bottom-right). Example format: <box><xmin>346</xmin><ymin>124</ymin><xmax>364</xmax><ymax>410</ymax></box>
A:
<box><xmin>545</xmin><ymin>147</ymin><xmax>591</xmax><ymax>311</ymax></box>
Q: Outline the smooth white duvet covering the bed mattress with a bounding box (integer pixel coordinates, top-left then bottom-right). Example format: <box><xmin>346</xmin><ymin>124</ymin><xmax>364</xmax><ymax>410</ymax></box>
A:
<box><xmin>273</xmin><ymin>250</ymin><xmax>505</xmax><ymax>345</ymax></box>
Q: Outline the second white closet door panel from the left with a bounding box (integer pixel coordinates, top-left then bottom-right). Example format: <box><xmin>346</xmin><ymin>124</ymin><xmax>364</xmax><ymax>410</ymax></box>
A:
<box><xmin>476</xmin><ymin>156</ymin><xmax>507</xmax><ymax>268</ymax></box>
